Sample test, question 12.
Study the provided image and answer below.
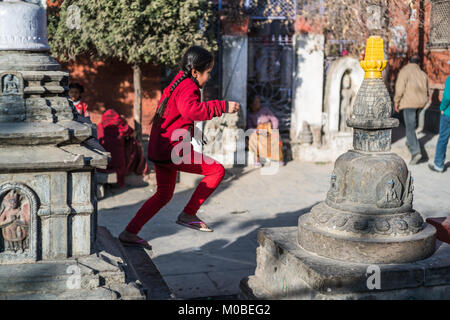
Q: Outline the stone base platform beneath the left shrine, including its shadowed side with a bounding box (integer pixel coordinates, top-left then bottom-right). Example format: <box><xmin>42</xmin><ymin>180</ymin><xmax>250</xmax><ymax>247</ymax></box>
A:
<box><xmin>0</xmin><ymin>227</ymin><xmax>172</xmax><ymax>300</ymax></box>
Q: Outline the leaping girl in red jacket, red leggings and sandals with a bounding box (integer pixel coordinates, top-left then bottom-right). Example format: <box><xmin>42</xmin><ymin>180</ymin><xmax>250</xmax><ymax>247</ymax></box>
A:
<box><xmin>119</xmin><ymin>46</ymin><xmax>240</xmax><ymax>249</ymax></box>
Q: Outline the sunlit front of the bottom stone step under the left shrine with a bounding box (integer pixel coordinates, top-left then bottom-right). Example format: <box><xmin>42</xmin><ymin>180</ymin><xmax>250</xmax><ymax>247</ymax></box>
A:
<box><xmin>0</xmin><ymin>260</ymin><xmax>100</xmax><ymax>294</ymax></box>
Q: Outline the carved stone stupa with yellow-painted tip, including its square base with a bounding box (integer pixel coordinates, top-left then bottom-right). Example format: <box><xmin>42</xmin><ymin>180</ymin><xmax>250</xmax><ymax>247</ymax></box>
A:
<box><xmin>241</xmin><ymin>36</ymin><xmax>450</xmax><ymax>299</ymax></box>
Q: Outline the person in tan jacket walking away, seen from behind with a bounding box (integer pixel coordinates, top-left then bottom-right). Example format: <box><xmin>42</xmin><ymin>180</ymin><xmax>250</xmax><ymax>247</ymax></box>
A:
<box><xmin>394</xmin><ymin>55</ymin><xmax>429</xmax><ymax>165</ymax></box>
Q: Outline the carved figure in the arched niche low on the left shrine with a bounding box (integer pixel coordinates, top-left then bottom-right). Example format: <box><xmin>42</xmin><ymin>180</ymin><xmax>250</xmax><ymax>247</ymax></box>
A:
<box><xmin>0</xmin><ymin>190</ymin><xmax>30</xmax><ymax>252</ymax></box>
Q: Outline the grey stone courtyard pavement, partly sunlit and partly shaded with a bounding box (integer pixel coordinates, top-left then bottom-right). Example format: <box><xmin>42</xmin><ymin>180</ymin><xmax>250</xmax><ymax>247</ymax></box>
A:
<box><xmin>98</xmin><ymin>159</ymin><xmax>450</xmax><ymax>299</ymax></box>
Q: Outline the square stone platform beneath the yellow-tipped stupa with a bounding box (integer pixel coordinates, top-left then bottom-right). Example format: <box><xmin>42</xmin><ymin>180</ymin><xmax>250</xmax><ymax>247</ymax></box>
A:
<box><xmin>240</xmin><ymin>227</ymin><xmax>450</xmax><ymax>300</ymax></box>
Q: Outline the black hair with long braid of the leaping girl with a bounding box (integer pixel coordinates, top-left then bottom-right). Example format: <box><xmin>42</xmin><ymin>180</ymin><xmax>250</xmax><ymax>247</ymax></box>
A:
<box><xmin>150</xmin><ymin>46</ymin><xmax>214</xmax><ymax>124</ymax></box>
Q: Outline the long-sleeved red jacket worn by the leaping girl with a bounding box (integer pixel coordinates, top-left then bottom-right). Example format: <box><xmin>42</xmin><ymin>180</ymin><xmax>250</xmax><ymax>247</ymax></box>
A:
<box><xmin>148</xmin><ymin>71</ymin><xmax>227</xmax><ymax>163</ymax></box>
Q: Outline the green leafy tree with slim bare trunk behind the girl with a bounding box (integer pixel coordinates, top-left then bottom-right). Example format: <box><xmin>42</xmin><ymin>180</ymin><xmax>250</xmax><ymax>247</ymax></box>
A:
<box><xmin>48</xmin><ymin>0</ymin><xmax>218</xmax><ymax>138</ymax></box>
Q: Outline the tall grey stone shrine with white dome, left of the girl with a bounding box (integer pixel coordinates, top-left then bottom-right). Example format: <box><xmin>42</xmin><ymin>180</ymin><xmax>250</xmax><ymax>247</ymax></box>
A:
<box><xmin>0</xmin><ymin>0</ymin><xmax>144</xmax><ymax>299</ymax></box>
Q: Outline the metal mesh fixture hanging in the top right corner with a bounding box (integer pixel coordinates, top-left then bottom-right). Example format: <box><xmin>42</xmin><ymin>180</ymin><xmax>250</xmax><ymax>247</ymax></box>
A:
<box><xmin>429</xmin><ymin>0</ymin><xmax>450</xmax><ymax>47</ymax></box>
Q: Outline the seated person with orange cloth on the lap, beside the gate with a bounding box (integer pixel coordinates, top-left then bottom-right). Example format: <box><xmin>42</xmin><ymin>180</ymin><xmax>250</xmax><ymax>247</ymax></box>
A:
<box><xmin>246</xmin><ymin>93</ymin><xmax>285</xmax><ymax>168</ymax></box>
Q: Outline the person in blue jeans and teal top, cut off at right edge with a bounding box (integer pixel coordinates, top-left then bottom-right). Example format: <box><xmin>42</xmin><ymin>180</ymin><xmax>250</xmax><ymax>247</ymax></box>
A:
<box><xmin>428</xmin><ymin>76</ymin><xmax>450</xmax><ymax>172</ymax></box>
